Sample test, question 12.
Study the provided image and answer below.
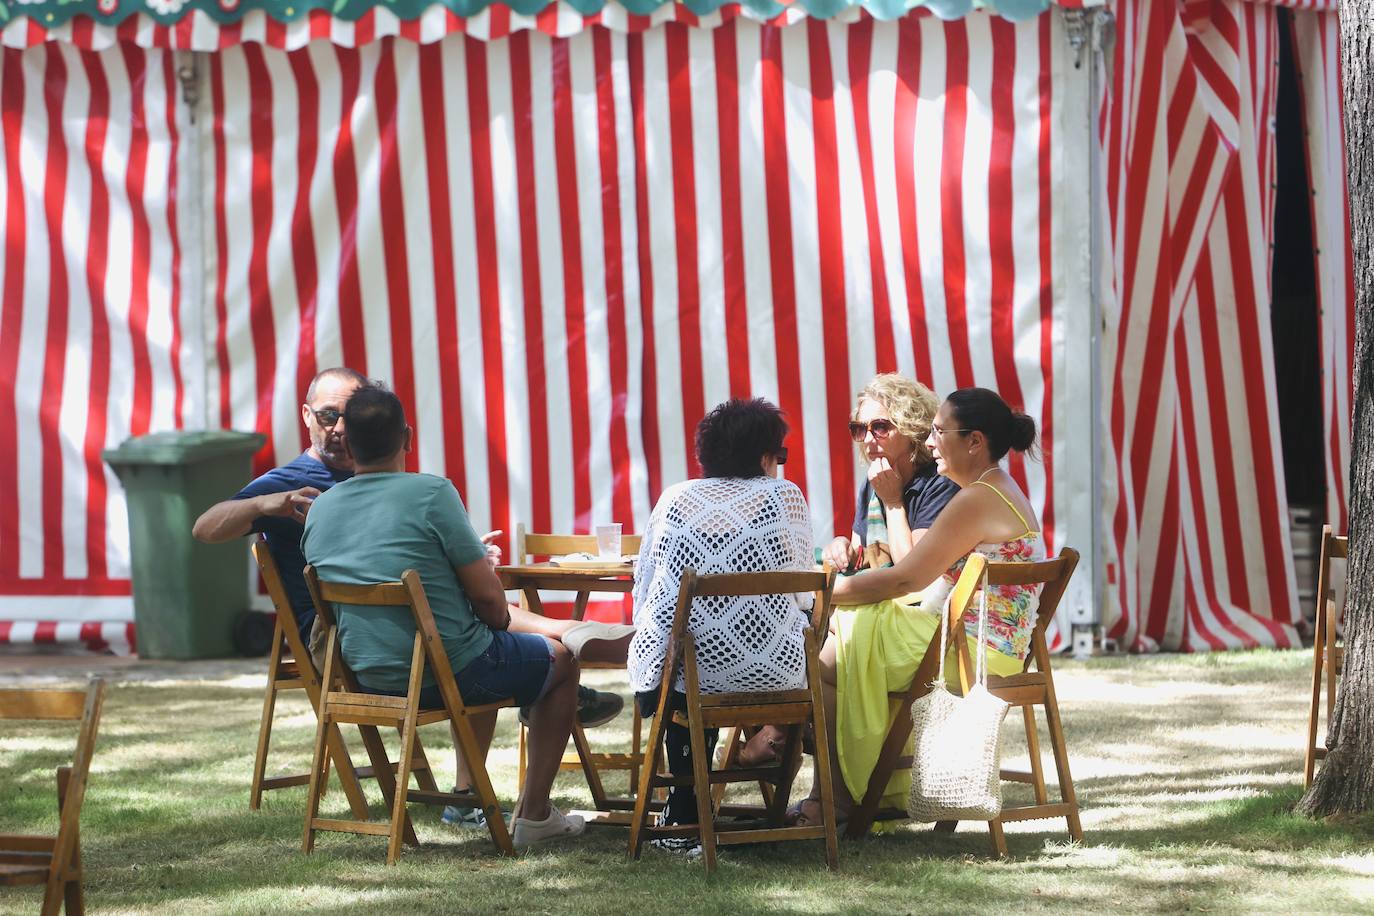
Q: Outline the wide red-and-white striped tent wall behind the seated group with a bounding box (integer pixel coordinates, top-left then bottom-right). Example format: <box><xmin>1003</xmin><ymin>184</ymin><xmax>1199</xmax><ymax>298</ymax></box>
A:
<box><xmin>0</xmin><ymin>7</ymin><xmax>1068</xmax><ymax>645</ymax></box>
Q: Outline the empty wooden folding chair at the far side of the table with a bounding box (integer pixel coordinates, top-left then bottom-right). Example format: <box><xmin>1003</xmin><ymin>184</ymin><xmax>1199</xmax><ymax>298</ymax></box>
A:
<box><xmin>513</xmin><ymin>522</ymin><xmax>643</xmax><ymax>810</ymax></box>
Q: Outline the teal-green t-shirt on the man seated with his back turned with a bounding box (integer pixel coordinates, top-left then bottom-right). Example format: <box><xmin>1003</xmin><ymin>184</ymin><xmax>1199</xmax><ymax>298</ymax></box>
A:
<box><xmin>301</xmin><ymin>474</ymin><xmax>492</xmax><ymax>691</ymax></box>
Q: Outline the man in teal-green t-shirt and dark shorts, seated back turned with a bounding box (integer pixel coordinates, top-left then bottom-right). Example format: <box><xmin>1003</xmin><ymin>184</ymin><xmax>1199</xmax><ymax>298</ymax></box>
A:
<box><xmin>301</xmin><ymin>383</ymin><xmax>584</xmax><ymax>849</ymax></box>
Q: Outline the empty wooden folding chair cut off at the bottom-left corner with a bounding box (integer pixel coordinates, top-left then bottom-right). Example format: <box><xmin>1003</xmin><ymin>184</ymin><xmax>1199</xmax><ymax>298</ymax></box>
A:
<box><xmin>0</xmin><ymin>678</ymin><xmax>104</xmax><ymax>916</ymax></box>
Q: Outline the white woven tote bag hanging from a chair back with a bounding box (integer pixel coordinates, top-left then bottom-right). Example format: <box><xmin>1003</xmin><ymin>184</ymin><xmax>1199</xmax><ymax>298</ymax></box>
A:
<box><xmin>907</xmin><ymin>573</ymin><xmax>1009</xmax><ymax>821</ymax></box>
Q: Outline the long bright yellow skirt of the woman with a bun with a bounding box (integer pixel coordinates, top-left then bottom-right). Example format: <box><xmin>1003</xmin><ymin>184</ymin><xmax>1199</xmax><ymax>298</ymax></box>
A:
<box><xmin>833</xmin><ymin>595</ymin><xmax>1024</xmax><ymax>809</ymax></box>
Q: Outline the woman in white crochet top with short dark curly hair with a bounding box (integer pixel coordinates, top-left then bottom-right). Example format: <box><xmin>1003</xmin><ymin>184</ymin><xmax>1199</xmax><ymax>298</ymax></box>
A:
<box><xmin>628</xmin><ymin>398</ymin><xmax>815</xmax><ymax>849</ymax></box>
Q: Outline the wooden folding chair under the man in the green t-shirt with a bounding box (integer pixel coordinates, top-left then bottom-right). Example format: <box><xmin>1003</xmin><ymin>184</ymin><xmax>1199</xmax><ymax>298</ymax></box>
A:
<box><xmin>304</xmin><ymin>566</ymin><xmax>515</xmax><ymax>865</ymax></box>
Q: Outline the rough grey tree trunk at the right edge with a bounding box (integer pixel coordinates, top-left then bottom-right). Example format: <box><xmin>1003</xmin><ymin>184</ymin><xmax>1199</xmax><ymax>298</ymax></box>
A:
<box><xmin>1297</xmin><ymin>0</ymin><xmax>1374</xmax><ymax>817</ymax></box>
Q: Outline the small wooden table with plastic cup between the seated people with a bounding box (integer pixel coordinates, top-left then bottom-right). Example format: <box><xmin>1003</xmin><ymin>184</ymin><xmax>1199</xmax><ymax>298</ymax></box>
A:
<box><xmin>496</xmin><ymin>563</ymin><xmax>642</xmax><ymax>827</ymax></box>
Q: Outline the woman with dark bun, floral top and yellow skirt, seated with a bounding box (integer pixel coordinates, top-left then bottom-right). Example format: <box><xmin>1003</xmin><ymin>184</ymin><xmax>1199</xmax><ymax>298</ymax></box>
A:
<box><xmin>797</xmin><ymin>389</ymin><xmax>1044</xmax><ymax>821</ymax></box>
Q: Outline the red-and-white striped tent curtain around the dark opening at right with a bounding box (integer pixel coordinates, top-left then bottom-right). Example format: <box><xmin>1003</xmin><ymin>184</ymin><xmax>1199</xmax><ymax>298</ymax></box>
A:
<box><xmin>1103</xmin><ymin>0</ymin><xmax>1349</xmax><ymax>651</ymax></box>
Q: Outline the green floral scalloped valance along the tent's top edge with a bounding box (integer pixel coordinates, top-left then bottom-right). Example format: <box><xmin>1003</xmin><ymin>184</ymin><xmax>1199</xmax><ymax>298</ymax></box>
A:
<box><xmin>0</xmin><ymin>0</ymin><xmax>1060</xmax><ymax>27</ymax></box>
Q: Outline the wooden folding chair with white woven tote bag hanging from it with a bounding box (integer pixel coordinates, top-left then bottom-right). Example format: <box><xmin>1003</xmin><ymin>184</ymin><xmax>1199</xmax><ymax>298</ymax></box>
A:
<box><xmin>845</xmin><ymin>547</ymin><xmax>1083</xmax><ymax>857</ymax></box>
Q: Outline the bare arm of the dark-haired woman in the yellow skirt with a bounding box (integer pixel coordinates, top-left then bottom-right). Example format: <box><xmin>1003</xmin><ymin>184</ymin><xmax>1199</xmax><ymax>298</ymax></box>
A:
<box><xmin>834</xmin><ymin>492</ymin><xmax>985</xmax><ymax>604</ymax></box>
